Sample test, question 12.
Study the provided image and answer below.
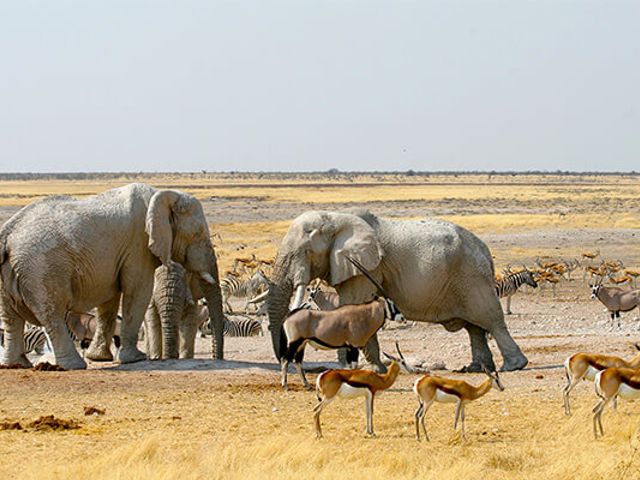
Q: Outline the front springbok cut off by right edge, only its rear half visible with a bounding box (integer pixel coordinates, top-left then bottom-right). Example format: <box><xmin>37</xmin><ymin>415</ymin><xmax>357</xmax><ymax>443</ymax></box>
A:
<box><xmin>593</xmin><ymin>368</ymin><xmax>640</xmax><ymax>438</ymax></box>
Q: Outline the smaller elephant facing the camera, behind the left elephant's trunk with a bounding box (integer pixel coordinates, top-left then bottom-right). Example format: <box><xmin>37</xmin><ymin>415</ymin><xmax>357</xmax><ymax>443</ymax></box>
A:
<box><xmin>144</xmin><ymin>262</ymin><xmax>209</xmax><ymax>360</ymax></box>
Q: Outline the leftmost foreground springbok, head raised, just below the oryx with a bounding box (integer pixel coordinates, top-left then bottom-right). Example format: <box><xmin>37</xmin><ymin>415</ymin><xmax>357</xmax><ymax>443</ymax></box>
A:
<box><xmin>313</xmin><ymin>361</ymin><xmax>400</xmax><ymax>438</ymax></box>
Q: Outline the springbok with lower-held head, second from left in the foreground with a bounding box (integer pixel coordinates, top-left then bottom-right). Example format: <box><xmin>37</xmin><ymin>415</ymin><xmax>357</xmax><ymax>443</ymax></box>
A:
<box><xmin>413</xmin><ymin>369</ymin><xmax>504</xmax><ymax>441</ymax></box>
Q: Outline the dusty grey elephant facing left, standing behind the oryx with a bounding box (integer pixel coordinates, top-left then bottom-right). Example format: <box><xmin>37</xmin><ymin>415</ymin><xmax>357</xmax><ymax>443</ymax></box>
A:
<box><xmin>267</xmin><ymin>210</ymin><xmax>527</xmax><ymax>371</ymax></box>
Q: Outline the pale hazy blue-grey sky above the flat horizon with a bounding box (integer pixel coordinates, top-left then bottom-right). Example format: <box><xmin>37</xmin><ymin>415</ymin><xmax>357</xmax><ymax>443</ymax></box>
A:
<box><xmin>0</xmin><ymin>0</ymin><xmax>640</xmax><ymax>172</ymax></box>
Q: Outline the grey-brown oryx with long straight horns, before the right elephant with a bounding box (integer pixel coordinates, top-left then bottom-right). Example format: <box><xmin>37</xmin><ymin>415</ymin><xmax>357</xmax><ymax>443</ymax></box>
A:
<box><xmin>281</xmin><ymin>257</ymin><xmax>405</xmax><ymax>390</ymax></box>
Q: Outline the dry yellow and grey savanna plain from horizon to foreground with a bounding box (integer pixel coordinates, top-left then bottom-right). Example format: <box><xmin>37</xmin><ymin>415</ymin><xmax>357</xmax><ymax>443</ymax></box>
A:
<box><xmin>0</xmin><ymin>173</ymin><xmax>640</xmax><ymax>480</ymax></box>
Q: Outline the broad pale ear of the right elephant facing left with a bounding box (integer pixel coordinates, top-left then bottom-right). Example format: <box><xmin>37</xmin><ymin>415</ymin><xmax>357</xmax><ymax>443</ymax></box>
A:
<box><xmin>329</xmin><ymin>215</ymin><xmax>382</xmax><ymax>285</ymax></box>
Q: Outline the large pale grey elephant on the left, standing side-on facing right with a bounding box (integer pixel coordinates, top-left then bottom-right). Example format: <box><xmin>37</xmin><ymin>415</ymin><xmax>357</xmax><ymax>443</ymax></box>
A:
<box><xmin>0</xmin><ymin>183</ymin><xmax>223</xmax><ymax>369</ymax></box>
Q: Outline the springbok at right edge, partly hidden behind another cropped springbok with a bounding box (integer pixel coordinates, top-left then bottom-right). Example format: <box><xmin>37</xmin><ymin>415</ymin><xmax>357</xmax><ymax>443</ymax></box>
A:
<box><xmin>562</xmin><ymin>343</ymin><xmax>640</xmax><ymax>415</ymax></box>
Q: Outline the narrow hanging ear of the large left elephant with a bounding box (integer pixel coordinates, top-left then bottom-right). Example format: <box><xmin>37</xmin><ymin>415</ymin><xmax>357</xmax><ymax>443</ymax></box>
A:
<box><xmin>145</xmin><ymin>190</ymin><xmax>180</xmax><ymax>265</ymax></box>
